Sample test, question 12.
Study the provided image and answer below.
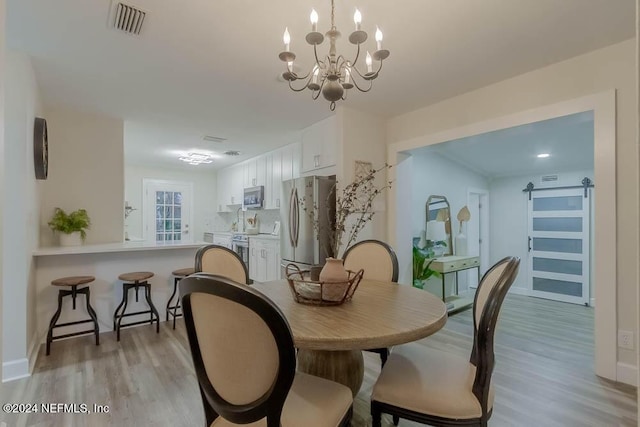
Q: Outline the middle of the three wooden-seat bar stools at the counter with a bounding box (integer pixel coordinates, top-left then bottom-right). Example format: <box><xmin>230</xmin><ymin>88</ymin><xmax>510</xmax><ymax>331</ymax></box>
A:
<box><xmin>113</xmin><ymin>271</ymin><xmax>160</xmax><ymax>341</ymax></box>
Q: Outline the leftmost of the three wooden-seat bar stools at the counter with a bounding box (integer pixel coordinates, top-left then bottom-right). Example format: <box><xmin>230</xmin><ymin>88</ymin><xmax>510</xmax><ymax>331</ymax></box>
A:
<box><xmin>47</xmin><ymin>276</ymin><xmax>100</xmax><ymax>356</ymax></box>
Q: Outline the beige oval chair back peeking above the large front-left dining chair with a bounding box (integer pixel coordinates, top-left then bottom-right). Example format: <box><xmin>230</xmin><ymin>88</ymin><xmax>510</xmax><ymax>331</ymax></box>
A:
<box><xmin>195</xmin><ymin>245</ymin><xmax>251</xmax><ymax>284</ymax></box>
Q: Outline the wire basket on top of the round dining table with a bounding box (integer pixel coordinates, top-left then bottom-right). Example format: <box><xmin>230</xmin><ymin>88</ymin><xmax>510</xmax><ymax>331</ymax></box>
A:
<box><xmin>285</xmin><ymin>258</ymin><xmax>364</xmax><ymax>306</ymax></box>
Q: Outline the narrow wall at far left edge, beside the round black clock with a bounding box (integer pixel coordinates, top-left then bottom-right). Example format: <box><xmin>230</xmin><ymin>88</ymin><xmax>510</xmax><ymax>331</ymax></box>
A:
<box><xmin>2</xmin><ymin>50</ymin><xmax>42</xmax><ymax>379</ymax></box>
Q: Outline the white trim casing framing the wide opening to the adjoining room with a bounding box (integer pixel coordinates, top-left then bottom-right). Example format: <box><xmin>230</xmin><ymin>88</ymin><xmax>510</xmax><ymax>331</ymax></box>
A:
<box><xmin>388</xmin><ymin>91</ymin><xmax>618</xmax><ymax>381</ymax></box>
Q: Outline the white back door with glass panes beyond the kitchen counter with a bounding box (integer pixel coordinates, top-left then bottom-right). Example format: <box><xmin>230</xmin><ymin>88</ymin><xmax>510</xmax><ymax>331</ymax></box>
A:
<box><xmin>143</xmin><ymin>179</ymin><xmax>193</xmax><ymax>243</ymax></box>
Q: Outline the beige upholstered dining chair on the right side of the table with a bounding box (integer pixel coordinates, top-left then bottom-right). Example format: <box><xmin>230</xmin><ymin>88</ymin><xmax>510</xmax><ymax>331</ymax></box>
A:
<box><xmin>371</xmin><ymin>257</ymin><xmax>520</xmax><ymax>427</ymax></box>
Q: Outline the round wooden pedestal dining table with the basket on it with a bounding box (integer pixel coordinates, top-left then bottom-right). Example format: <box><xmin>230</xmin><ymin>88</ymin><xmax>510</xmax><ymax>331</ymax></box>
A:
<box><xmin>253</xmin><ymin>279</ymin><xmax>447</xmax><ymax>396</ymax></box>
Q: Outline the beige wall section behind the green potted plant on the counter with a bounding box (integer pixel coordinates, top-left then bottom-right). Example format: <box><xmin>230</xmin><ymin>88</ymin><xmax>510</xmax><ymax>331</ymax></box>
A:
<box><xmin>40</xmin><ymin>107</ymin><xmax>124</xmax><ymax>247</ymax></box>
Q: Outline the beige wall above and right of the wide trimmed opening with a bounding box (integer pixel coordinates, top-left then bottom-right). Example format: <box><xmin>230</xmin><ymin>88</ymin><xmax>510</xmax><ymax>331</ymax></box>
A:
<box><xmin>387</xmin><ymin>39</ymin><xmax>639</xmax><ymax>372</ymax></box>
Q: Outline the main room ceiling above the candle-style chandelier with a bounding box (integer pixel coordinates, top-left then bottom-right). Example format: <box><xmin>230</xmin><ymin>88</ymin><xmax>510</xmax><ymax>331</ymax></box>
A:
<box><xmin>7</xmin><ymin>0</ymin><xmax>635</xmax><ymax>168</ymax></box>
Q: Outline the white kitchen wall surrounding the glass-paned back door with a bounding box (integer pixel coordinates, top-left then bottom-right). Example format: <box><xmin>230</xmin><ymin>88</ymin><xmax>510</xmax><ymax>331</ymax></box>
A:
<box><xmin>124</xmin><ymin>164</ymin><xmax>216</xmax><ymax>240</ymax></box>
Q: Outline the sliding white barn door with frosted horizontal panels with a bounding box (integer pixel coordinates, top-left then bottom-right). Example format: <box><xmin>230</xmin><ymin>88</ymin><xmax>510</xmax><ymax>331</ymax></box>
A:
<box><xmin>528</xmin><ymin>189</ymin><xmax>590</xmax><ymax>305</ymax></box>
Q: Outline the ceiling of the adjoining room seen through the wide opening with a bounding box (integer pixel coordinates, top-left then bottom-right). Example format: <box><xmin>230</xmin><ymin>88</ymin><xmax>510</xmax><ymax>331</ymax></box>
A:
<box><xmin>412</xmin><ymin>111</ymin><xmax>594</xmax><ymax>179</ymax></box>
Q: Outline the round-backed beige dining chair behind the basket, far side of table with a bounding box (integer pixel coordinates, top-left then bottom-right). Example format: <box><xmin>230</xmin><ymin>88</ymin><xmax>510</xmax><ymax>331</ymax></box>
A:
<box><xmin>343</xmin><ymin>240</ymin><xmax>398</xmax><ymax>366</ymax></box>
